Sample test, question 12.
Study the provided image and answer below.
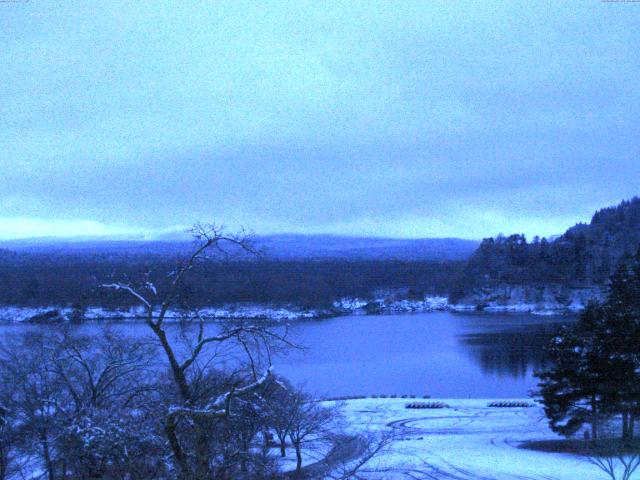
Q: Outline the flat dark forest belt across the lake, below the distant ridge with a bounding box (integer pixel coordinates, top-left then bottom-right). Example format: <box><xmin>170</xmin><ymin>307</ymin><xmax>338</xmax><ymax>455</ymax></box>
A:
<box><xmin>0</xmin><ymin>251</ymin><xmax>463</xmax><ymax>307</ymax></box>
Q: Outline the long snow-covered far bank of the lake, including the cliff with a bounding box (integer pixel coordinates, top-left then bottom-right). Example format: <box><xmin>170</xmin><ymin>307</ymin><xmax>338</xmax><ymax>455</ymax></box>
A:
<box><xmin>0</xmin><ymin>285</ymin><xmax>602</xmax><ymax>323</ymax></box>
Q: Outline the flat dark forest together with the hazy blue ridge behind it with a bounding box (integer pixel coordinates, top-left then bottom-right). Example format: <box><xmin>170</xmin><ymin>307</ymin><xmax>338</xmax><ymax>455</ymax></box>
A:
<box><xmin>0</xmin><ymin>235</ymin><xmax>478</xmax><ymax>314</ymax></box>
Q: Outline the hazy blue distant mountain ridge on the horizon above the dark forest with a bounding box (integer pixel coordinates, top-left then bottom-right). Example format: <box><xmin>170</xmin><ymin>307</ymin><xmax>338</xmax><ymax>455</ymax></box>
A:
<box><xmin>0</xmin><ymin>234</ymin><xmax>480</xmax><ymax>261</ymax></box>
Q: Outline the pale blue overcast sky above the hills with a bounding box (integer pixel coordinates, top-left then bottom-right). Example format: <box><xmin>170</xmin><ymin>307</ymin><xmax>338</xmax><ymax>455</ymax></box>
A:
<box><xmin>0</xmin><ymin>0</ymin><xmax>640</xmax><ymax>239</ymax></box>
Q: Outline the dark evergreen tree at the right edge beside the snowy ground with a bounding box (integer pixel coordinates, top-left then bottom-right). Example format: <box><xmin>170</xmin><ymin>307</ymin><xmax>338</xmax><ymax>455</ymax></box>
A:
<box><xmin>538</xmin><ymin>250</ymin><xmax>640</xmax><ymax>441</ymax></box>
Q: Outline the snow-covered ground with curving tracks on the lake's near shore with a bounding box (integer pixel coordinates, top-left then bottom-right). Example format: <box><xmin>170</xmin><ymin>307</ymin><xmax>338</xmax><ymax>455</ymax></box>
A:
<box><xmin>336</xmin><ymin>399</ymin><xmax>608</xmax><ymax>480</ymax></box>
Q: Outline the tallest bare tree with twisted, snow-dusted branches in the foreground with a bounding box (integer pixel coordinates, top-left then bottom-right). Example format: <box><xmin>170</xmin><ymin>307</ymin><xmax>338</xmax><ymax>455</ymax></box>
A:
<box><xmin>103</xmin><ymin>225</ymin><xmax>290</xmax><ymax>480</ymax></box>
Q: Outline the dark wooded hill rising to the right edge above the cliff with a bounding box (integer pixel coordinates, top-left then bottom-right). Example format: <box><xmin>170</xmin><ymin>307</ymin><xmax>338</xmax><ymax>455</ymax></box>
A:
<box><xmin>452</xmin><ymin>197</ymin><xmax>640</xmax><ymax>300</ymax></box>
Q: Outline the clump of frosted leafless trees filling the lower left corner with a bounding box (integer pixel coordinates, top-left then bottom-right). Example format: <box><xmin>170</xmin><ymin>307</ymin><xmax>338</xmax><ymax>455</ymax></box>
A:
<box><xmin>0</xmin><ymin>330</ymin><xmax>164</xmax><ymax>480</ymax></box>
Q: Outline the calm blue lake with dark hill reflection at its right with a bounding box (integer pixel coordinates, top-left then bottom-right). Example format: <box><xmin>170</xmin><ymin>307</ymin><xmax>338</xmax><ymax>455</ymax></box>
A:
<box><xmin>0</xmin><ymin>312</ymin><xmax>571</xmax><ymax>398</ymax></box>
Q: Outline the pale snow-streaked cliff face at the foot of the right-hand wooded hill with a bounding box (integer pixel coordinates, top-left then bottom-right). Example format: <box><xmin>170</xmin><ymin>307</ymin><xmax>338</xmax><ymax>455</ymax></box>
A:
<box><xmin>450</xmin><ymin>284</ymin><xmax>604</xmax><ymax>315</ymax></box>
